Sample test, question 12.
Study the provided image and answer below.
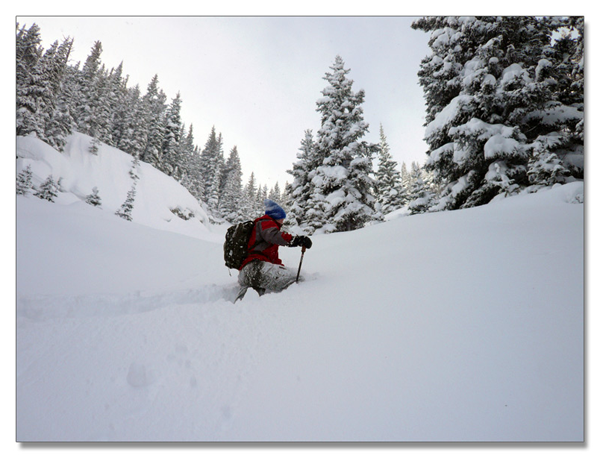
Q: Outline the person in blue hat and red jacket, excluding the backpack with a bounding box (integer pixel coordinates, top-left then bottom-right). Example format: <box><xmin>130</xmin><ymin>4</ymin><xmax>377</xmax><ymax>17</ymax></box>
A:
<box><xmin>238</xmin><ymin>199</ymin><xmax>312</xmax><ymax>295</ymax></box>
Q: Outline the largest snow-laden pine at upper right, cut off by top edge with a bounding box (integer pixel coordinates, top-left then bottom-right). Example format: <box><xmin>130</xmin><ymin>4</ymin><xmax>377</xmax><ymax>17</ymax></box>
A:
<box><xmin>413</xmin><ymin>17</ymin><xmax>578</xmax><ymax>210</ymax></box>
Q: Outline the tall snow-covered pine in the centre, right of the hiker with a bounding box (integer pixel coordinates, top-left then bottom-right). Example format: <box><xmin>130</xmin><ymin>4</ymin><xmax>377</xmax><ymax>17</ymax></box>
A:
<box><xmin>307</xmin><ymin>56</ymin><xmax>378</xmax><ymax>233</ymax></box>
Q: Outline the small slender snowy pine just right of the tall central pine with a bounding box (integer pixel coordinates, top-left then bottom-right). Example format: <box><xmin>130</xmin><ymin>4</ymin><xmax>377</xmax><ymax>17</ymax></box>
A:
<box><xmin>375</xmin><ymin>125</ymin><xmax>406</xmax><ymax>215</ymax></box>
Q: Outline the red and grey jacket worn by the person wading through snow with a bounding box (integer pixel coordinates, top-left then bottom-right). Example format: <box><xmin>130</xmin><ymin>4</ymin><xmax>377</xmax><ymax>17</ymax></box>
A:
<box><xmin>240</xmin><ymin>215</ymin><xmax>293</xmax><ymax>270</ymax></box>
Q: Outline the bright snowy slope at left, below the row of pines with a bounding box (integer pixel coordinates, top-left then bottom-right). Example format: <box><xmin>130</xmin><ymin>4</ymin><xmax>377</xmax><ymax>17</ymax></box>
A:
<box><xmin>17</xmin><ymin>133</ymin><xmax>221</xmax><ymax>240</ymax></box>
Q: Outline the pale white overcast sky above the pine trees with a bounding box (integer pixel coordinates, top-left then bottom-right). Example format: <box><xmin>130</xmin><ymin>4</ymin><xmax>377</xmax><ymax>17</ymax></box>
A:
<box><xmin>17</xmin><ymin>16</ymin><xmax>429</xmax><ymax>188</ymax></box>
